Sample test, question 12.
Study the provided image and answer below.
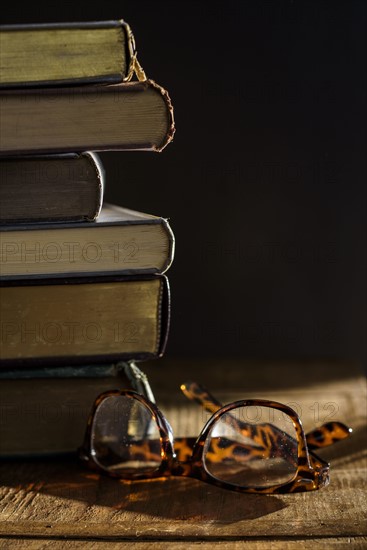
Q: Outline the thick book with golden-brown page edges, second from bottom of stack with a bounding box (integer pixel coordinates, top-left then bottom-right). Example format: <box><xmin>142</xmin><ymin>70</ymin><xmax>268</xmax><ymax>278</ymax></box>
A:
<box><xmin>0</xmin><ymin>275</ymin><xmax>170</xmax><ymax>368</ymax></box>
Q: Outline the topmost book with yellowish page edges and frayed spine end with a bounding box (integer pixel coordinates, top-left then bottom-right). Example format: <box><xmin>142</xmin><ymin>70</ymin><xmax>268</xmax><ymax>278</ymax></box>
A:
<box><xmin>0</xmin><ymin>20</ymin><xmax>147</xmax><ymax>87</ymax></box>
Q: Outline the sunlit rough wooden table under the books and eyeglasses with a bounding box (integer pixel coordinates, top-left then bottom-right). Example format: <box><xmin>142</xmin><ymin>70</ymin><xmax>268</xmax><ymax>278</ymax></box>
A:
<box><xmin>0</xmin><ymin>358</ymin><xmax>367</xmax><ymax>550</ymax></box>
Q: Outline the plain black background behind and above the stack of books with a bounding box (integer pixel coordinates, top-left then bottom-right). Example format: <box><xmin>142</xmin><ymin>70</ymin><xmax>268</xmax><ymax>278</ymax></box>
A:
<box><xmin>2</xmin><ymin>0</ymin><xmax>366</xmax><ymax>370</ymax></box>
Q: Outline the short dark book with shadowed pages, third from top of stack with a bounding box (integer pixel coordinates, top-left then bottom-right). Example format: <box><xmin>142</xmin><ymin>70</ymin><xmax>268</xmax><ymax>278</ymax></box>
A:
<box><xmin>0</xmin><ymin>152</ymin><xmax>105</xmax><ymax>223</ymax></box>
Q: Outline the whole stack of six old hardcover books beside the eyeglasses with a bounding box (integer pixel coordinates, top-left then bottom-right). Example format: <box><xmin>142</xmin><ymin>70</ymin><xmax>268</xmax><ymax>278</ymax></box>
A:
<box><xmin>0</xmin><ymin>21</ymin><xmax>175</xmax><ymax>456</ymax></box>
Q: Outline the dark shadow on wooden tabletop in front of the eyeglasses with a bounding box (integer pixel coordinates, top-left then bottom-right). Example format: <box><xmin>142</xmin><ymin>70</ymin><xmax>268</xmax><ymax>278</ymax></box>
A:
<box><xmin>0</xmin><ymin>457</ymin><xmax>288</xmax><ymax>523</ymax></box>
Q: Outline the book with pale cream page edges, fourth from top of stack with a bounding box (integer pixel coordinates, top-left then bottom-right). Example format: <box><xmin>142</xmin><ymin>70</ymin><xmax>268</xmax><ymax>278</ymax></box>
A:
<box><xmin>0</xmin><ymin>203</ymin><xmax>175</xmax><ymax>279</ymax></box>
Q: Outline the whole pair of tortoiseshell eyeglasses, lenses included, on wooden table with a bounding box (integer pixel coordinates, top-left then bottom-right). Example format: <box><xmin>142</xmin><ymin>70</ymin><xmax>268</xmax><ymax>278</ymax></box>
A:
<box><xmin>79</xmin><ymin>382</ymin><xmax>352</xmax><ymax>493</ymax></box>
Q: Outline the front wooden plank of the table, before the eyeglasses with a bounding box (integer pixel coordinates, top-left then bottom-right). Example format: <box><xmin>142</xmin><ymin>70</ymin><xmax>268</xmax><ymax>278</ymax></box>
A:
<box><xmin>0</xmin><ymin>459</ymin><xmax>367</xmax><ymax>540</ymax></box>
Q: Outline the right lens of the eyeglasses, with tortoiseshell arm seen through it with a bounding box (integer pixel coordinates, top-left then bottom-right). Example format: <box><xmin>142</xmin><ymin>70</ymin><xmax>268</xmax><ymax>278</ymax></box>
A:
<box><xmin>204</xmin><ymin>406</ymin><xmax>298</xmax><ymax>488</ymax></box>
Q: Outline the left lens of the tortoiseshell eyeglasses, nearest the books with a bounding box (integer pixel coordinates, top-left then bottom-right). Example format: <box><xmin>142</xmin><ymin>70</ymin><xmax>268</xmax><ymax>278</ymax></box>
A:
<box><xmin>91</xmin><ymin>395</ymin><xmax>161</xmax><ymax>474</ymax></box>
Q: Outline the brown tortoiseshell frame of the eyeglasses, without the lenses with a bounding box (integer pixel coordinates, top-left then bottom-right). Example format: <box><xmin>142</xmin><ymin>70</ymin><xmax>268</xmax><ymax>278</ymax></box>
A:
<box><xmin>79</xmin><ymin>382</ymin><xmax>352</xmax><ymax>494</ymax></box>
